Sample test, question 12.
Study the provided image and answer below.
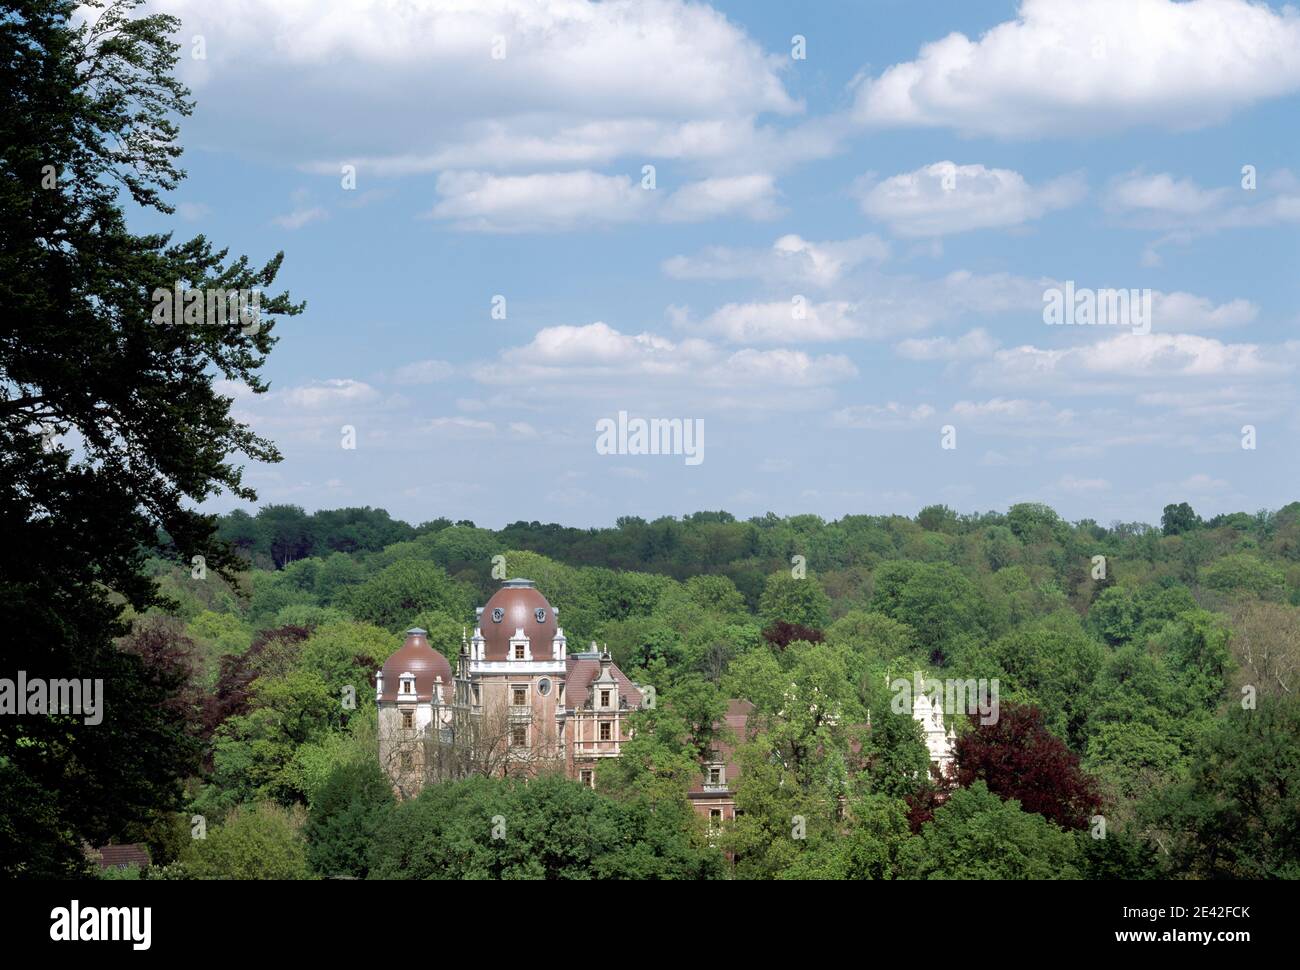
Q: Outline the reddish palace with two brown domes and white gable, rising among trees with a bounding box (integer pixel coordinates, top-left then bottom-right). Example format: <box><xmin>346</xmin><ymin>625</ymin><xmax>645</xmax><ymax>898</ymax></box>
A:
<box><xmin>374</xmin><ymin>579</ymin><xmax>952</xmax><ymax>824</ymax></box>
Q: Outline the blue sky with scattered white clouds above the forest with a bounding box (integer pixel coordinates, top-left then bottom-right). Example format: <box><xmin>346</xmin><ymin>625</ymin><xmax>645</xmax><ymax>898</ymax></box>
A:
<box><xmin>122</xmin><ymin>0</ymin><xmax>1300</xmax><ymax>527</ymax></box>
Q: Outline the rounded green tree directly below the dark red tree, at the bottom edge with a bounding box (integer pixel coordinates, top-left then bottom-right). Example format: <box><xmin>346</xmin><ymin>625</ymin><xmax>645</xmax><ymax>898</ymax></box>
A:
<box><xmin>898</xmin><ymin>781</ymin><xmax>1080</xmax><ymax>879</ymax></box>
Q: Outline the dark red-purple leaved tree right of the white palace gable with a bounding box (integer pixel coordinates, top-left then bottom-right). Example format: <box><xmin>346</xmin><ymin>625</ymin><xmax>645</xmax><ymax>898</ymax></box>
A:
<box><xmin>953</xmin><ymin>703</ymin><xmax>1101</xmax><ymax>828</ymax></box>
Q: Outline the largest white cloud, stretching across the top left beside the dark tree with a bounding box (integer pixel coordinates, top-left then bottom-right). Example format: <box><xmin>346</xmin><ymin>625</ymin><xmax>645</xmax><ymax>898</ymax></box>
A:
<box><xmin>151</xmin><ymin>0</ymin><xmax>811</xmax><ymax>178</ymax></box>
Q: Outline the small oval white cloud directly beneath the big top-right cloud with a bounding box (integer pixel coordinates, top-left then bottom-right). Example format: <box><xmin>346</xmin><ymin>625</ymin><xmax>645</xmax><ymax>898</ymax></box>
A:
<box><xmin>855</xmin><ymin>161</ymin><xmax>1087</xmax><ymax>237</ymax></box>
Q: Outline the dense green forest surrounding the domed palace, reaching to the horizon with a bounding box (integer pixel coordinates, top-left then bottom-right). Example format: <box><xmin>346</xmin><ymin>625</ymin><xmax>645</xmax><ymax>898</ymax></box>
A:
<box><xmin>81</xmin><ymin>494</ymin><xmax>1300</xmax><ymax>879</ymax></box>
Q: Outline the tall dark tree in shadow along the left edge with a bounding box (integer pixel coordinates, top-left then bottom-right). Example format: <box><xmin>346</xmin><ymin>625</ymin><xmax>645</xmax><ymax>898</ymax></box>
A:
<box><xmin>0</xmin><ymin>0</ymin><xmax>302</xmax><ymax>874</ymax></box>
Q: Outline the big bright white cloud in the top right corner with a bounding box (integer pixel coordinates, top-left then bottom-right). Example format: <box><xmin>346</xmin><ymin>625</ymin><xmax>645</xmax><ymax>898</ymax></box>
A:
<box><xmin>855</xmin><ymin>0</ymin><xmax>1300</xmax><ymax>137</ymax></box>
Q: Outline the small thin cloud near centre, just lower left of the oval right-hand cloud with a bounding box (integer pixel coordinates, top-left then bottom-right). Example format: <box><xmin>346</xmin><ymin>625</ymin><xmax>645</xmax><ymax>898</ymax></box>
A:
<box><xmin>663</xmin><ymin>233</ymin><xmax>889</xmax><ymax>286</ymax></box>
